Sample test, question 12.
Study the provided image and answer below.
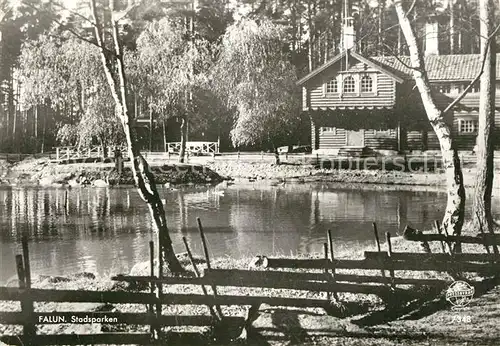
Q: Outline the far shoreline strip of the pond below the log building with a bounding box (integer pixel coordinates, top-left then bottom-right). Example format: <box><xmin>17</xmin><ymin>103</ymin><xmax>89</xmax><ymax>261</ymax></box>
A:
<box><xmin>0</xmin><ymin>159</ymin><xmax>492</xmax><ymax>188</ymax></box>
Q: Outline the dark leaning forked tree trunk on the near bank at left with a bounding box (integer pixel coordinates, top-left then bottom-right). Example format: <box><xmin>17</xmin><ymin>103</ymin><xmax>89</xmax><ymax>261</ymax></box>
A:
<box><xmin>90</xmin><ymin>0</ymin><xmax>184</xmax><ymax>273</ymax></box>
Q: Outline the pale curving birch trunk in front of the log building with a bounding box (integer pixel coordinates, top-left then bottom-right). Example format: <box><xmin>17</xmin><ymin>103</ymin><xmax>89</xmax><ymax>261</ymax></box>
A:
<box><xmin>394</xmin><ymin>0</ymin><xmax>465</xmax><ymax>238</ymax></box>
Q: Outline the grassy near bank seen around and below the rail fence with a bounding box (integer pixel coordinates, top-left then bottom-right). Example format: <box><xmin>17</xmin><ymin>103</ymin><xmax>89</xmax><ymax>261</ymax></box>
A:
<box><xmin>0</xmin><ymin>232</ymin><xmax>500</xmax><ymax>346</ymax></box>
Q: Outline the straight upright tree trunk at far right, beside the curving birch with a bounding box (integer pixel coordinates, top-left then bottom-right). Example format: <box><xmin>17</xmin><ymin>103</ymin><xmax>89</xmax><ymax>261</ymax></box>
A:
<box><xmin>472</xmin><ymin>0</ymin><xmax>496</xmax><ymax>232</ymax></box>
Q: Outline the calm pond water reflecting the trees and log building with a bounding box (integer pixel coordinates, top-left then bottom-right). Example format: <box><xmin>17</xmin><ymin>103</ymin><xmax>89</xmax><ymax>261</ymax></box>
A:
<box><xmin>0</xmin><ymin>183</ymin><xmax>492</xmax><ymax>284</ymax></box>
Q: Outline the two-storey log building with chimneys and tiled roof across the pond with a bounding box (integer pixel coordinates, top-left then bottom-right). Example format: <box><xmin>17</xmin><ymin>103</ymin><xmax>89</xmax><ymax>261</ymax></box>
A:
<box><xmin>297</xmin><ymin>18</ymin><xmax>500</xmax><ymax>156</ymax></box>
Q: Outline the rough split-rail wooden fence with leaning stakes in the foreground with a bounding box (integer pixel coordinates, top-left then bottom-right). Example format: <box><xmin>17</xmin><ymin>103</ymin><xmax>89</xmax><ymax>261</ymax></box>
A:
<box><xmin>0</xmin><ymin>219</ymin><xmax>500</xmax><ymax>345</ymax></box>
